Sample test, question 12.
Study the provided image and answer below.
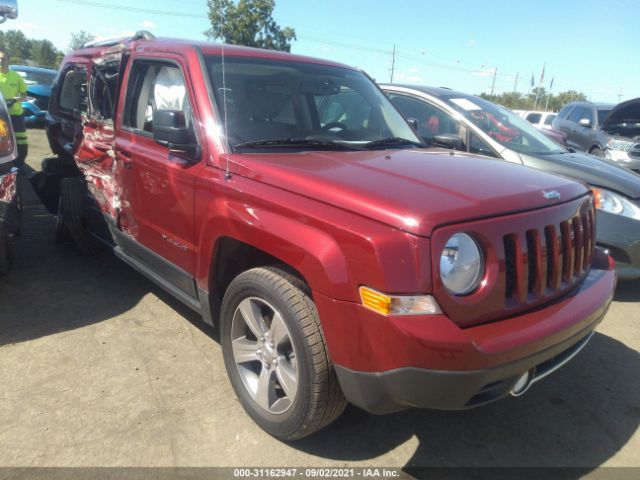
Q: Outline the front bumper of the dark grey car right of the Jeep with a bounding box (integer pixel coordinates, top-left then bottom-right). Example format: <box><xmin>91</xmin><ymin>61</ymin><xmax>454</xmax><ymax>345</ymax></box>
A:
<box><xmin>596</xmin><ymin>210</ymin><xmax>640</xmax><ymax>280</ymax></box>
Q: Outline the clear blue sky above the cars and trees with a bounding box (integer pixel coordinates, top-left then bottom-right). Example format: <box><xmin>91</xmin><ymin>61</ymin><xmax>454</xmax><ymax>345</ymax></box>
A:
<box><xmin>10</xmin><ymin>0</ymin><xmax>640</xmax><ymax>102</ymax></box>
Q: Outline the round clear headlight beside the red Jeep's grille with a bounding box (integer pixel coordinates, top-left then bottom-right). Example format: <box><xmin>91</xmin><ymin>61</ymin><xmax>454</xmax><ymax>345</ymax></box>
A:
<box><xmin>440</xmin><ymin>233</ymin><xmax>484</xmax><ymax>295</ymax></box>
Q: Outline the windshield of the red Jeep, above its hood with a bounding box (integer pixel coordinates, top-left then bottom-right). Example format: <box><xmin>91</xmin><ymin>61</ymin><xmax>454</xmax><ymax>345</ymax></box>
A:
<box><xmin>206</xmin><ymin>55</ymin><xmax>420</xmax><ymax>151</ymax></box>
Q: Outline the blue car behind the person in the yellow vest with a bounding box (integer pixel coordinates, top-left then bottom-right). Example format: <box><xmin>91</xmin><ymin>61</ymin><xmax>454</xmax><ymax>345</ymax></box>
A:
<box><xmin>9</xmin><ymin>65</ymin><xmax>58</xmax><ymax>128</ymax></box>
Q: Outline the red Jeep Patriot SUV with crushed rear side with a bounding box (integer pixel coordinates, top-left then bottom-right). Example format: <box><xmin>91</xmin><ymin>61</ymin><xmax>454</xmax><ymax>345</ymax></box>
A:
<box><xmin>42</xmin><ymin>34</ymin><xmax>615</xmax><ymax>439</ymax></box>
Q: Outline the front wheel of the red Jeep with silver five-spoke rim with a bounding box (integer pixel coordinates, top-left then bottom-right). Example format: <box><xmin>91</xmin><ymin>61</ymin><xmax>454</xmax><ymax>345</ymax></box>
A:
<box><xmin>220</xmin><ymin>267</ymin><xmax>346</xmax><ymax>440</ymax></box>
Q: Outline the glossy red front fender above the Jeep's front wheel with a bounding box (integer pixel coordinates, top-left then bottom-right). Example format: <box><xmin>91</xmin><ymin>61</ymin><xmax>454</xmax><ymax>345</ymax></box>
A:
<box><xmin>196</xmin><ymin>170</ymin><xmax>431</xmax><ymax>301</ymax></box>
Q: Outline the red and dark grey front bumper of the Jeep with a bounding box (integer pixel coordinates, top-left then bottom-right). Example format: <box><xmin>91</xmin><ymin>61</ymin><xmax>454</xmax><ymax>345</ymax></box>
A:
<box><xmin>316</xmin><ymin>253</ymin><xmax>616</xmax><ymax>413</ymax></box>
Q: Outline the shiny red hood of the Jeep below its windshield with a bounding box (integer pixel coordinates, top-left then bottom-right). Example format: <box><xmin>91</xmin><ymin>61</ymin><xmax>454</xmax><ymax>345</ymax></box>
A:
<box><xmin>229</xmin><ymin>149</ymin><xmax>587</xmax><ymax>236</ymax></box>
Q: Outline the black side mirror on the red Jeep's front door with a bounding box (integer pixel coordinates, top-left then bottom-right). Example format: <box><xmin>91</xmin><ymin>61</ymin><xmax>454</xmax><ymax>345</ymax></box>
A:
<box><xmin>153</xmin><ymin>110</ymin><xmax>202</xmax><ymax>162</ymax></box>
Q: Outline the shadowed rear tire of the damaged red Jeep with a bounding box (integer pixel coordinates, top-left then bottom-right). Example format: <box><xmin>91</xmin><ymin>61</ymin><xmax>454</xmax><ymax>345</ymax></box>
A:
<box><xmin>56</xmin><ymin>178</ymin><xmax>96</xmax><ymax>255</ymax></box>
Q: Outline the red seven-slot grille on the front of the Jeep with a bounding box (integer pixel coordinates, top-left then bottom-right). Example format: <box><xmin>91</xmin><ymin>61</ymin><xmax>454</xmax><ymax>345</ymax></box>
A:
<box><xmin>503</xmin><ymin>209</ymin><xmax>595</xmax><ymax>307</ymax></box>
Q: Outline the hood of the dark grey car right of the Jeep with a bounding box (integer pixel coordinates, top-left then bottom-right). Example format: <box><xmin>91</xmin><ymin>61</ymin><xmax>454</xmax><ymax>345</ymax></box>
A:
<box><xmin>520</xmin><ymin>153</ymin><xmax>640</xmax><ymax>199</ymax></box>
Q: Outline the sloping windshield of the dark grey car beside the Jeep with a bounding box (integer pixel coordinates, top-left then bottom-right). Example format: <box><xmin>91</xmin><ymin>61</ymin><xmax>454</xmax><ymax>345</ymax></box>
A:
<box><xmin>445</xmin><ymin>96</ymin><xmax>565</xmax><ymax>155</ymax></box>
